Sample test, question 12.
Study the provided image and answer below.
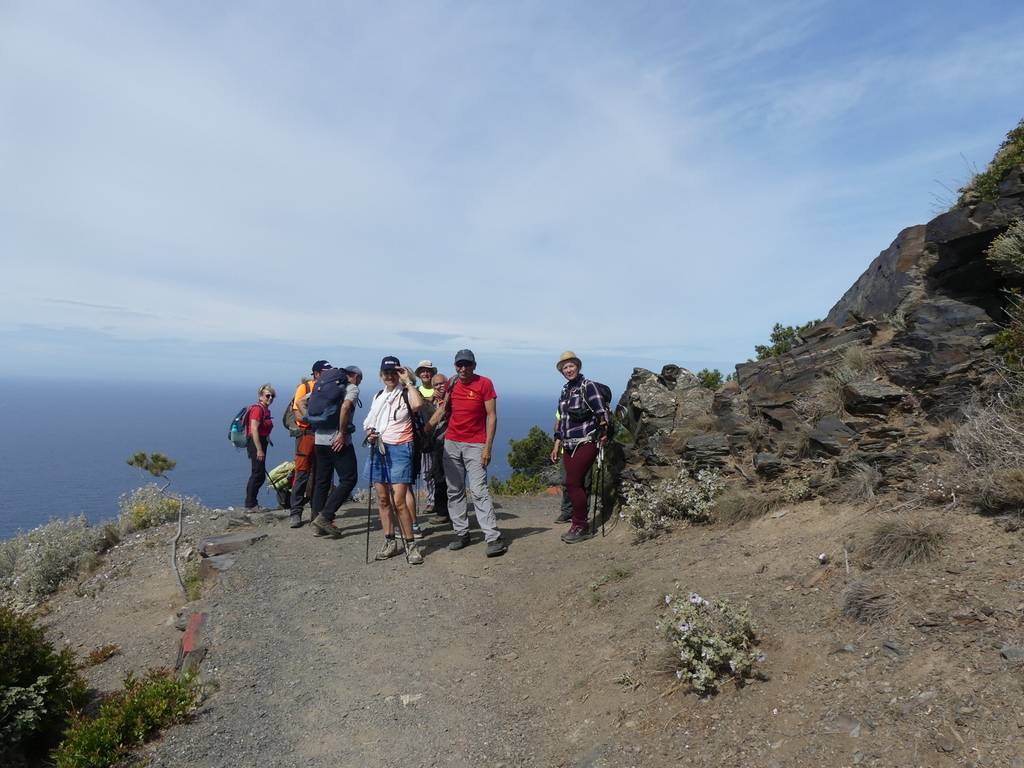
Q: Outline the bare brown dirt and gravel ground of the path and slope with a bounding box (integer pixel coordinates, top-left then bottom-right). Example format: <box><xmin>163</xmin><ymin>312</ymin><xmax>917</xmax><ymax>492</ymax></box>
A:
<box><xmin>48</xmin><ymin>497</ymin><xmax>1024</xmax><ymax>768</ymax></box>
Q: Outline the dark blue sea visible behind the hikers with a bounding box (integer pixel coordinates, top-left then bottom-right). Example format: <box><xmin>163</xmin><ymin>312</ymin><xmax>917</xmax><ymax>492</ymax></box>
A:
<box><xmin>0</xmin><ymin>377</ymin><xmax>554</xmax><ymax>539</ymax></box>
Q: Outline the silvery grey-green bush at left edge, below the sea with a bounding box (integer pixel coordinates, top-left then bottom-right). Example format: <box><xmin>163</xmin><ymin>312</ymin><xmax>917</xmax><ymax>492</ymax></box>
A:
<box><xmin>0</xmin><ymin>515</ymin><xmax>119</xmax><ymax>602</ymax></box>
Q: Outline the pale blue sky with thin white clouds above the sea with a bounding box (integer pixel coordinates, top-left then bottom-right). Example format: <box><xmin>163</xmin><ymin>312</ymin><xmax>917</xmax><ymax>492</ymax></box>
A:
<box><xmin>0</xmin><ymin>0</ymin><xmax>1024</xmax><ymax>392</ymax></box>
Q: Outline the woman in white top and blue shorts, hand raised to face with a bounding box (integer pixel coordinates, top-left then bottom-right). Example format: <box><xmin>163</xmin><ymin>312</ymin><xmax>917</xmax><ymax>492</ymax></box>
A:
<box><xmin>362</xmin><ymin>355</ymin><xmax>423</xmax><ymax>565</ymax></box>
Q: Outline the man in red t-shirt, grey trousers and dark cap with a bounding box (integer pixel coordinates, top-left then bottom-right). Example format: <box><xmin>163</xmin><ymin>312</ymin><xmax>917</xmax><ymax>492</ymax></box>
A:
<box><xmin>444</xmin><ymin>349</ymin><xmax>508</xmax><ymax>557</ymax></box>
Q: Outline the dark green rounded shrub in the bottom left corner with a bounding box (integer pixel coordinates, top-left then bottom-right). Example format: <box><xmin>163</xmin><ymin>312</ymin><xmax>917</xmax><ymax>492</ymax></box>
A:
<box><xmin>0</xmin><ymin>606</ymin><xmax>85</xmax><ymax>765</ymax></box>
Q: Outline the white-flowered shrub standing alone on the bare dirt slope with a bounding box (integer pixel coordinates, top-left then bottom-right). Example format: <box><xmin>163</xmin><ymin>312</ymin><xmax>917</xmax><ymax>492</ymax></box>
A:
<box><xmin>658</xmin><ymin>592</ymin><xmax>763</xmax><ymax>695</ymax></box>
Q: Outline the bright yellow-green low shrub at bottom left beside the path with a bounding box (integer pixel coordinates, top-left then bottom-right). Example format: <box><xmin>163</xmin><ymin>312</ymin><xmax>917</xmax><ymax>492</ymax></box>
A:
<box><xmin>53</xmin><ymin>670</ymin><xmax>199</xmax><ymax>768</ymax></box>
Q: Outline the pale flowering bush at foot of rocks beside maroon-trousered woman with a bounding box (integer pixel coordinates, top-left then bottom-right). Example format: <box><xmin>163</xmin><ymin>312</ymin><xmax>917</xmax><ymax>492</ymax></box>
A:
<box><xmin>620</xmin><ymin>469</ymin><xmax>725</xmax><ymax>541</ymax></box>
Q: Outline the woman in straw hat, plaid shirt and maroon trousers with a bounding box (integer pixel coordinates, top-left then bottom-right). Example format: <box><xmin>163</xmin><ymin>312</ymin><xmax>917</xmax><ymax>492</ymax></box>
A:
<box><xmin>551</xmin><ymin>351</ymin><xmax>608</xmax><ymax>544</ymax></box>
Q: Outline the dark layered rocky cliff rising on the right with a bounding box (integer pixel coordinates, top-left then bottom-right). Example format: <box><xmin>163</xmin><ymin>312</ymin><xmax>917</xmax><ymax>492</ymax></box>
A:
<box><xmin>618</xmin><ymin>166</ymin><xmax>1024</xmax><ymax>494</ymax></box>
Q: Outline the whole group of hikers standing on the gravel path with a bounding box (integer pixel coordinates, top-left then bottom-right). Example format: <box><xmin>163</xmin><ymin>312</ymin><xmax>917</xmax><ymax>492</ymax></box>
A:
<box><xmin>240</xmin><ymin>349</ymin><xmax>611</xmax><ymax>565</ymax></box>
